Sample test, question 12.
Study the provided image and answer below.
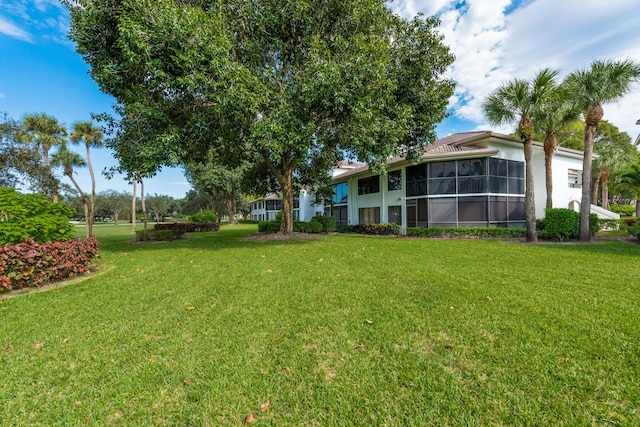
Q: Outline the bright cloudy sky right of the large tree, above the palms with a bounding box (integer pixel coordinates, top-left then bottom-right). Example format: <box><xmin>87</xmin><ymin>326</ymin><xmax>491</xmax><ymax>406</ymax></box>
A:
<box><xmin>391</xmin><ymin>0</ymin><xmax>640</xmax><ymax>136</ymax></box>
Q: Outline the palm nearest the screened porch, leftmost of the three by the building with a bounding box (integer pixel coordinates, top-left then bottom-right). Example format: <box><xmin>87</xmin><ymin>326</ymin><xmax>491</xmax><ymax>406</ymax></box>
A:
<box><xmin>482</xmin><ymin>68</ymin><xmax>558</xmax><ymax>242</ymax></box>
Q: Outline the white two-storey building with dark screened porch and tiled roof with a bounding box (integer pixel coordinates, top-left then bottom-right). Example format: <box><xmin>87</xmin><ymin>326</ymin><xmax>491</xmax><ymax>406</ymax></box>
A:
<box><xmin>332</xmin><ymin>131</ymin><xmax>616</xmax><ymax>230</ymax></box>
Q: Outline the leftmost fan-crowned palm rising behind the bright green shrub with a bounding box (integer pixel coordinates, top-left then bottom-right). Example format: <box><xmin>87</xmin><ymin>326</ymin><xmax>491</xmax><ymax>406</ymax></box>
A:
<box><xmin>22</xmin><ymin>113</ymin><xmax>67</xmax><ymax>202</ymax></box>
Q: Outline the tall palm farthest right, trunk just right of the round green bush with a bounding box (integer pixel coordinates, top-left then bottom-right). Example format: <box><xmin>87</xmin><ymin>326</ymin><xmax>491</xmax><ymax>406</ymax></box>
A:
<box><xmin>567</xmin><ymin>60</ymin><xmax>640</xmax><ymax>242</ymax></box>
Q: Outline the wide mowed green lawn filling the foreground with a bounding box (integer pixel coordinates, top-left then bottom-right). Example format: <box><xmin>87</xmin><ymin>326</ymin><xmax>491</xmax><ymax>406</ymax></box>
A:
<box><xmin>0</xmin><ymin>225</ymin><xmax>640</xmax><ymax>426</ymax></box>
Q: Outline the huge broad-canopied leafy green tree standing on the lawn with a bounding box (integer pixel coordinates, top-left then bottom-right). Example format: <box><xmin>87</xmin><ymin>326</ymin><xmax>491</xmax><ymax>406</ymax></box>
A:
<box><xmin>69</xmin><ymin>0</ymin><xmax>453</xmax><ymax>233</ymax></box>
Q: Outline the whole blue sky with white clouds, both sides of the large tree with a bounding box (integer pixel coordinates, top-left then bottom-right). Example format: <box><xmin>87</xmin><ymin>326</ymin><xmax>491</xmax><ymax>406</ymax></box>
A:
<box><xmin>0</xmin><ymin>0</ymin><xmax>640</xmax><ymax>198</ymax></box>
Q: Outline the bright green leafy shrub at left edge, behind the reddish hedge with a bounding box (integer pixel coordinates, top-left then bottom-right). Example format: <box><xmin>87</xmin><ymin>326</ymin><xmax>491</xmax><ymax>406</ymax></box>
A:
<box><xmin>0</xmin><ymin>187</ymin><xmax>74</xmax><ymax>245</ymax></box>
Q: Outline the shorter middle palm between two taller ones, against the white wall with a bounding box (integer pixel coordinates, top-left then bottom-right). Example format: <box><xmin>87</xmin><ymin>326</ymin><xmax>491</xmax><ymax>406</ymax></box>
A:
<box><xmin>533</xmin><ymin>84</ymin><xmax>580</xmax><ymax>208</ymax></box>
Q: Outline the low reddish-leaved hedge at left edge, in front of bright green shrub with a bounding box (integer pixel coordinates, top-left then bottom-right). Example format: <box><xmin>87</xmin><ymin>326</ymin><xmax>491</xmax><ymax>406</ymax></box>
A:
<box><xmin>0</xmin><ymin>237</ymin><xmax>100</xmax><ymax>291</ymax></box>
